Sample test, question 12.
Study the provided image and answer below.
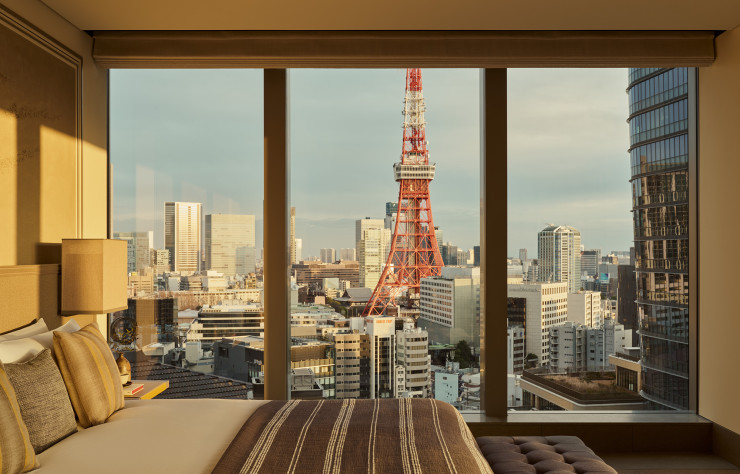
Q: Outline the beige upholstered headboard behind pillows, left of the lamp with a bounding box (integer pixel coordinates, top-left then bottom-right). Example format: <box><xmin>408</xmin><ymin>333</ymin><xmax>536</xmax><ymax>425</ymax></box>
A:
<box><xmin>0</xmin><ymin>264</ymin><xmax>61</xmax><ymax>333</ymax></box>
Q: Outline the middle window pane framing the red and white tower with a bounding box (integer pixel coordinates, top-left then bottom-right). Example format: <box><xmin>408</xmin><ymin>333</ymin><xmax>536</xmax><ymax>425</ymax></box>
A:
<box><xmin>289</xmin><ymin>69</ymin><xmax>480</xmax><ymax>410</ymax></box>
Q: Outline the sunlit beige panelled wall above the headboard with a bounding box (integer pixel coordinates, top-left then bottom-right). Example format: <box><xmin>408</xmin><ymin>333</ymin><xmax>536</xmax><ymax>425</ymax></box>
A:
<box><xmin>0</xmin><ymin>0</ymin><xmax>108</xmax><ymax>328</ymax></box>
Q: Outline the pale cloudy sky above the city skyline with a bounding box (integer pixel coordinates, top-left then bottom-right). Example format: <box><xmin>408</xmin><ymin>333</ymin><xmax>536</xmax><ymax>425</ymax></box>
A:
<box><xmin>110</xmin><ymin>69</ymin><xmax>632</xmax><ymax>257</ymax></box>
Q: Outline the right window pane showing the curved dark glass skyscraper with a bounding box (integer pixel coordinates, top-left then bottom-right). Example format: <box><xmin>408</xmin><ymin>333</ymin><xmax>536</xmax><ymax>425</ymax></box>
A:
<box><xmin>507</xmin><ymin>68</ymin><xmax>696</xmax><ymax>411</ymax></box>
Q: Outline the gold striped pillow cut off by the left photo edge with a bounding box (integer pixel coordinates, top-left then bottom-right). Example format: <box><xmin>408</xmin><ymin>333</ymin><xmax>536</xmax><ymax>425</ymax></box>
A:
<box><xmin>0</xmin><ymin>362</ymin><xmax>36</xmax><ymax>473</ymax></box>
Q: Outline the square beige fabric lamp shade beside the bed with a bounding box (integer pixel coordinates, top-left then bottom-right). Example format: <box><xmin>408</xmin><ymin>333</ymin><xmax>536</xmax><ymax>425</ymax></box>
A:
<box><xmin>62</xmin><ymin>239</ymin><xmax>128</xmax><ymax>315</ymax></box>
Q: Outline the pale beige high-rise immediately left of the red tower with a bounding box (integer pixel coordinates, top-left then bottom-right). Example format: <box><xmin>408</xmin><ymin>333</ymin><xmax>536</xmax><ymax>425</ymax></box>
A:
<box><xmin>355</xmin><ymin>217</ymin><xmax>391</xmax><ymax>289</ymax></box>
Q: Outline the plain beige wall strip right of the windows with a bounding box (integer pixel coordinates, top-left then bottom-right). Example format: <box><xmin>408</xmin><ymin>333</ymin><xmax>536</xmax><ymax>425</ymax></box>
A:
<box><xmin>698</xmin><ymin>28</ymin><xmax>740</xmax><ymax>433</ymax></box>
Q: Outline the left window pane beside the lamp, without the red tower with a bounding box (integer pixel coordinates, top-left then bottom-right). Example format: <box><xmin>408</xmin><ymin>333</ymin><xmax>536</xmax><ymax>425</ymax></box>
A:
<box><xmin>109</xmin><ymin>69</ymin><xmax>264</xmax><ymax>398</ymax></box>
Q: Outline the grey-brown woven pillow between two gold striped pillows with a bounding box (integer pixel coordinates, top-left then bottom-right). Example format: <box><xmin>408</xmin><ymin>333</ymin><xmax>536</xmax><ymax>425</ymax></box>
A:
<box><xmin>5</xmin><ymin>349</ymin><xmax>77</xmax><ymax>454</ymax></box>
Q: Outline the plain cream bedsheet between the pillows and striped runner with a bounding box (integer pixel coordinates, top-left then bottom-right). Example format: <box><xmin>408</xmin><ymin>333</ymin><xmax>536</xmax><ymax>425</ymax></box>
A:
<box><xmin>34</xmin><ymin>399</ymin><xmax>265</xmax><ymax>474</ymax></box>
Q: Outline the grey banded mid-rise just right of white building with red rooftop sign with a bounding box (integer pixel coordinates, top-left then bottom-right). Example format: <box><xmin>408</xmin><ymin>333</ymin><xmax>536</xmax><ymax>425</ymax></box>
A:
<box><xmin>396</xmin><ymin>323</ymin><xmax>432</xmax><ymax>398</ymax></box>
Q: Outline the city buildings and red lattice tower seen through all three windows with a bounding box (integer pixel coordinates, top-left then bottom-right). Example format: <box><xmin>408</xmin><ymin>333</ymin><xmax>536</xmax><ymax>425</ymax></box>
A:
<box><xmin>110</xmin><ymin>68</ymin><xmax>696</xmax><ymax>411</ymax></box>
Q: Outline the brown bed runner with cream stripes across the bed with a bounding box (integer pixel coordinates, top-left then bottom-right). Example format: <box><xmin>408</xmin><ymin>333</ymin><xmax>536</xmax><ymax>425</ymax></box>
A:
<box><xmin>213</xmin><ymin>398</ymin><xmax>491</xmax><ymax>474</ymax></box>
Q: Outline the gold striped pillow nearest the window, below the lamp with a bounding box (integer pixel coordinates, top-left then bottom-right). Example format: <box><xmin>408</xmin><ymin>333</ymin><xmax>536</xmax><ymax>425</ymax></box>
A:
<box><xmin>54</xmin><ymin>322</ymin><xmax>123</xmax><ymax>428</ymax></box>
